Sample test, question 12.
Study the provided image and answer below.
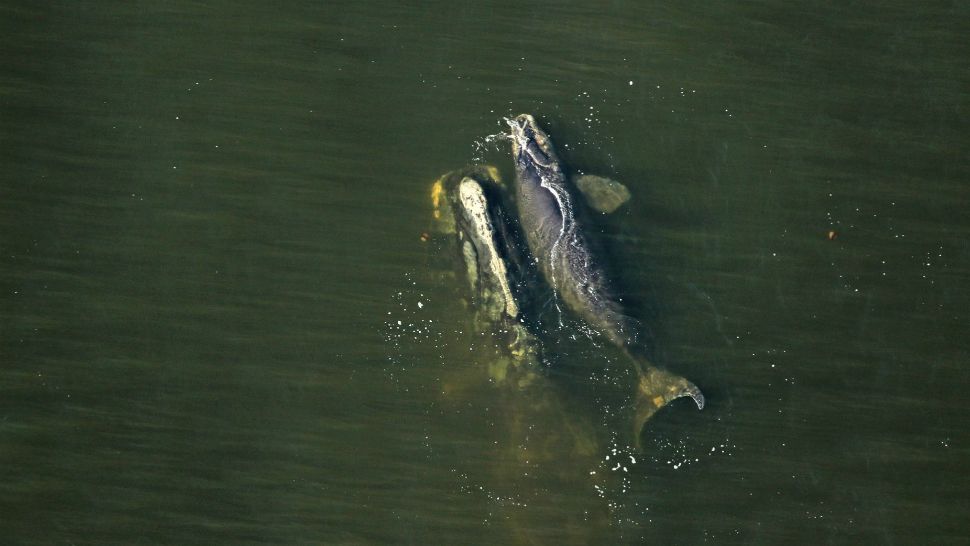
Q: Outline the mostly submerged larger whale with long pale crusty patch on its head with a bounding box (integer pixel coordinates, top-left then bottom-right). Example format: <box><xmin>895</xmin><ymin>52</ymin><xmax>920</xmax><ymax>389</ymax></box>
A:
<box><xmin>431</xmin><ymin>165</ymin><xmax>617</xmax><ymax>544</ymax></box>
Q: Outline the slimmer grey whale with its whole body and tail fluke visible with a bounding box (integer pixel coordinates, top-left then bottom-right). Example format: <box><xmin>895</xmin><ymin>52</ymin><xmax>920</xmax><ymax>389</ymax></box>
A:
<box><xmin>508</xmin><ymin>114</ymin><xmax>704</xmax><ymax>444</ymax></box>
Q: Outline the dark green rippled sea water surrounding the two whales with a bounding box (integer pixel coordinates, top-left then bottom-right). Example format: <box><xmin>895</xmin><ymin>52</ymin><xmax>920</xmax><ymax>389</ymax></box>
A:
<box><xmin>0</xmin><ymin>0</ymin><xmax>970</xmax><ymax>544</ymax></box>
